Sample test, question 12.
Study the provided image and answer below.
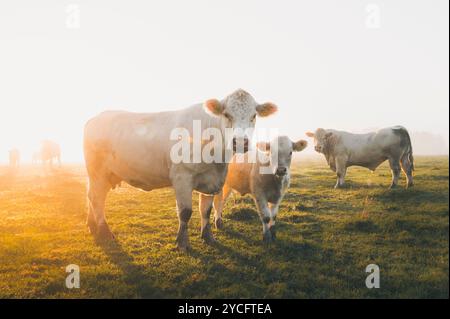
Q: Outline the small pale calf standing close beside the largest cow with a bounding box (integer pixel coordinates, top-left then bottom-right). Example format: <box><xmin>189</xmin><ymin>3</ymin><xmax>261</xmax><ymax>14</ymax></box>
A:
<box><xmin>214</xmin><ymin>136</ymin><xmax>308</xmax><ymax>242</ymax></box>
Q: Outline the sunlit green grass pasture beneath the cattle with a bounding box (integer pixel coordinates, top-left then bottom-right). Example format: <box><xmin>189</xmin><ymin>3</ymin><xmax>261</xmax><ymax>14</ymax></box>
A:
<box><xmin>0</xmin><ymin>157</ymin><xmax>449</xmax><ymax>298</ymax></box>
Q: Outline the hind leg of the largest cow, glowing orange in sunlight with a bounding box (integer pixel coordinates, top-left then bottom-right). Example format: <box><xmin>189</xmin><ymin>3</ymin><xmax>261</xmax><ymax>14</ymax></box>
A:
<box><xmin>87</xmin><ymin>178</ymin><xmax>114</xmax><ymax>240</ymax></box>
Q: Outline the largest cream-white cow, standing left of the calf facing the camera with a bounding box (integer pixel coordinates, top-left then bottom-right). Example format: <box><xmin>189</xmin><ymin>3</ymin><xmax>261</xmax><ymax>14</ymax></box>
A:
<box><xmin>84</xmin><ymin>90</ymin><xmax>277</xmax><ymax>250</ymax></box>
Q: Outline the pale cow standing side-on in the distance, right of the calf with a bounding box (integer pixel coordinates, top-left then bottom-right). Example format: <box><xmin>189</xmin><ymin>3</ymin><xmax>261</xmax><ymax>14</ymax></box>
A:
<box><xmin>306</xmin><ymin>126</ymin><xmax>414</xmax><ymax>188</ymax></box>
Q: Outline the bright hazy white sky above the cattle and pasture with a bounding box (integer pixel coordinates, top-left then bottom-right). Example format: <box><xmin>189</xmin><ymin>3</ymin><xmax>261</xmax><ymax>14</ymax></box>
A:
<box><xmin>0</xmin><ymin>0</ymin><xmax>449</xmax><ymax>161</ymax></box>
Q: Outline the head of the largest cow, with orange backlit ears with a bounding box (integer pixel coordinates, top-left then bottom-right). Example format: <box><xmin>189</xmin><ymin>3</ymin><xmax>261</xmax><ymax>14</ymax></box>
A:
<box><xmin>204</xmin><ymin>89</ymin><xmax>277</xmax><ymax>152</ymax></box>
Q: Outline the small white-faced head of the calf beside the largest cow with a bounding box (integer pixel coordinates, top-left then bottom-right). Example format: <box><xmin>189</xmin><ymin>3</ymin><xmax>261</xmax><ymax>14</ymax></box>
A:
<box><xmin>257</xmin><ymin>136</ymin><xmax>308</xmax><ymax>177</ymax></box>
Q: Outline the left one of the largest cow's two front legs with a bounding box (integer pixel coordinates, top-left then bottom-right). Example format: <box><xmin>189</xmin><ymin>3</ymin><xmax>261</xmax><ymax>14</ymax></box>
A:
<box><xmin>174</xmin><ymin>179</ymin><xmax>193</xmax><ymax>251</ymax></box>
